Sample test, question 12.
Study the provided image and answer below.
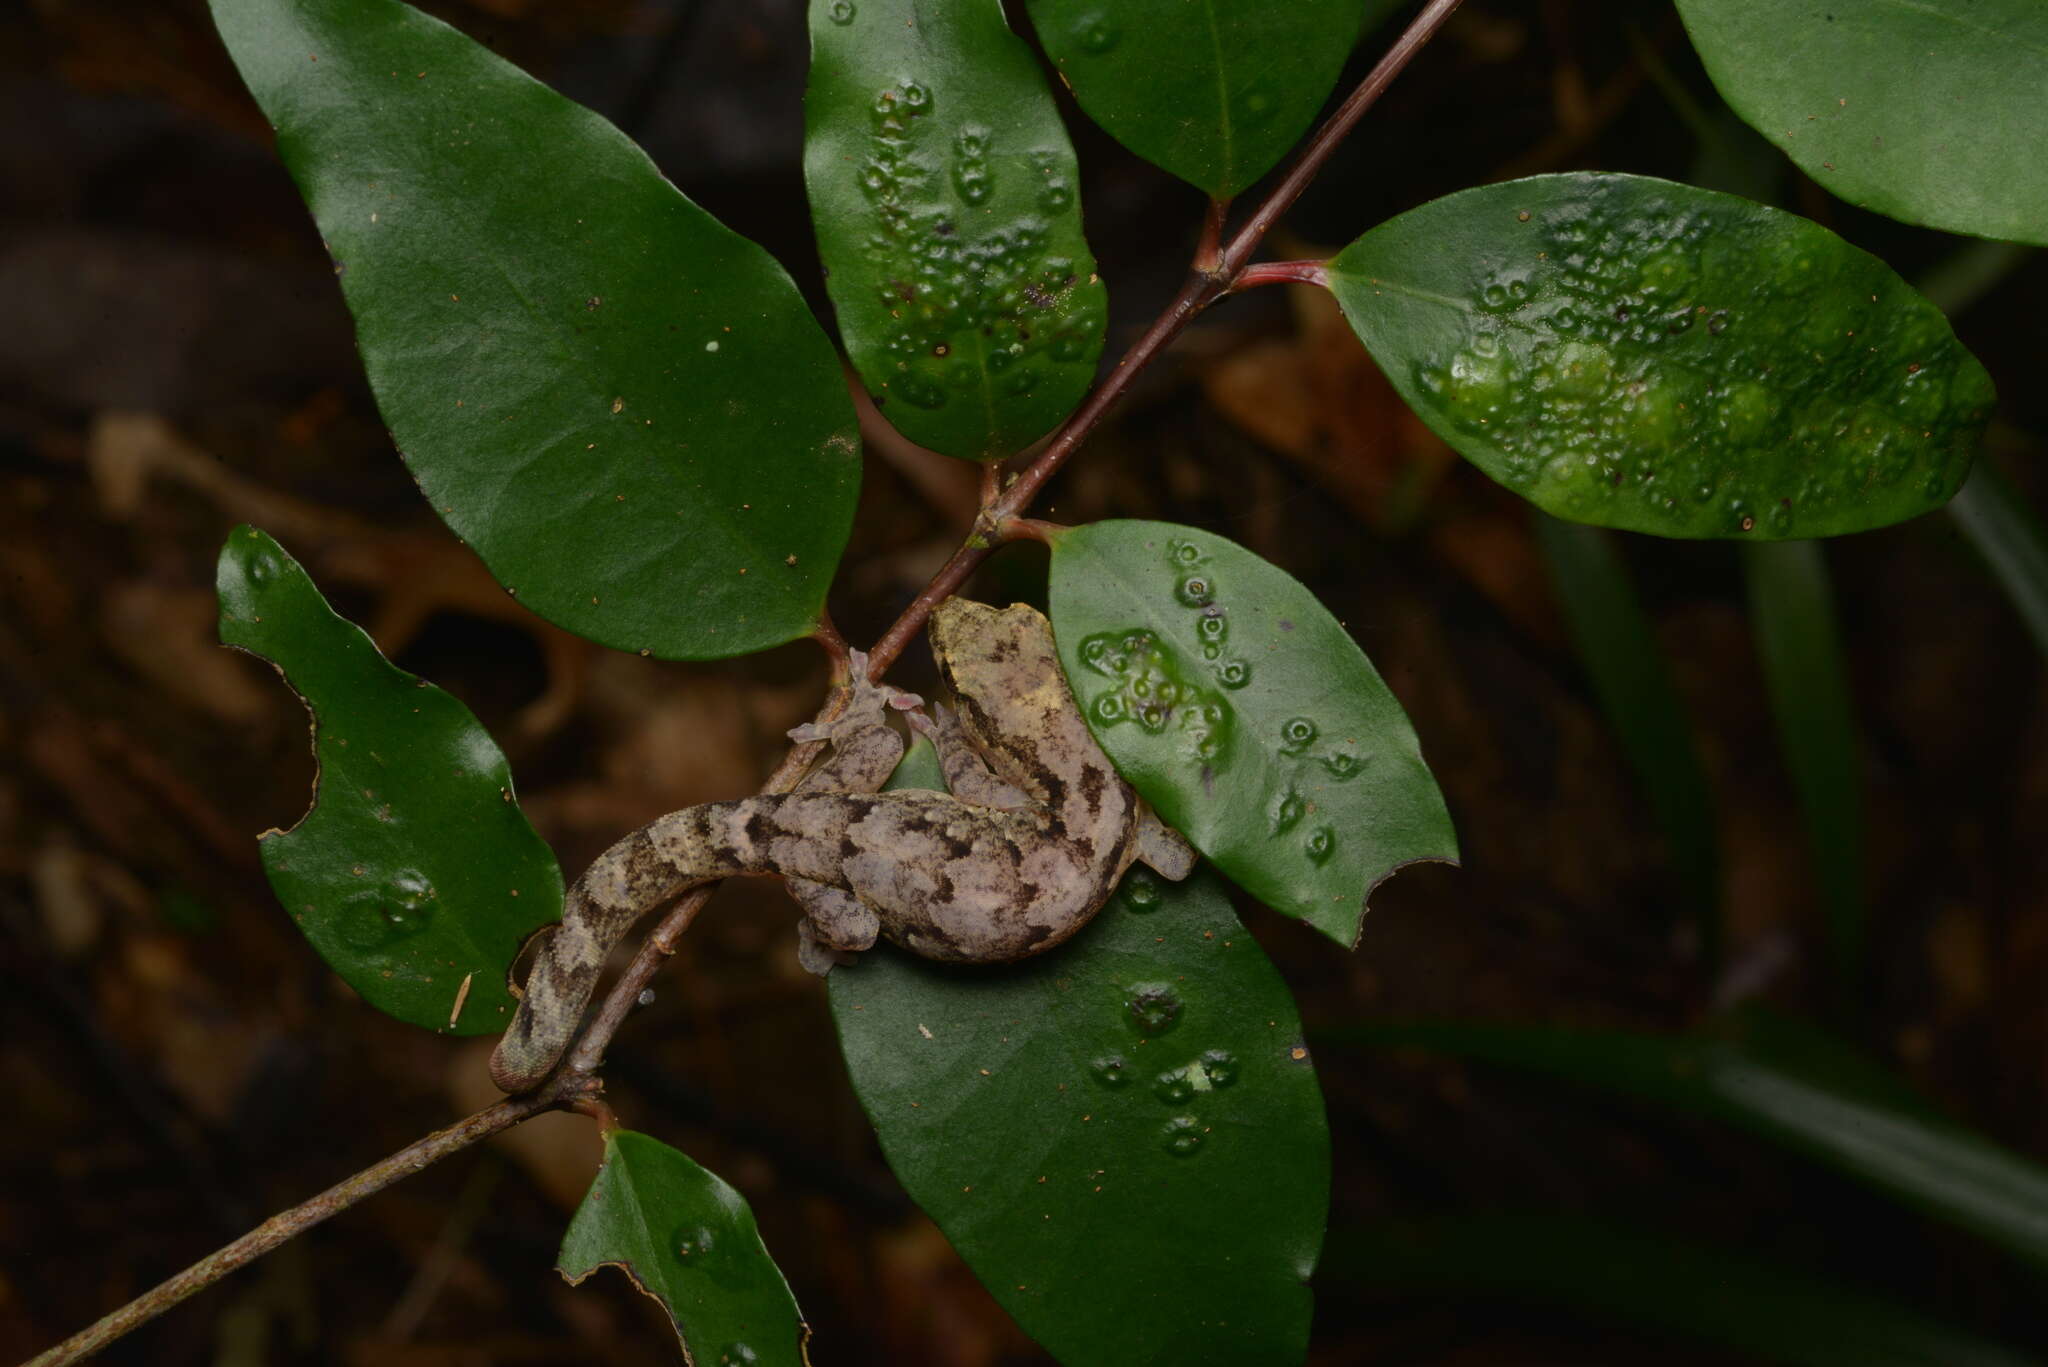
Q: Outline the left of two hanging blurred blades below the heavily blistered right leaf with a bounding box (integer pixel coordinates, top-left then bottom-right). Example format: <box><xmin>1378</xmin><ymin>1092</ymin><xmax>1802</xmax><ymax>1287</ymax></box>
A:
<box><xmin>1536</xmin><ymin>510</ymin><xmax>1720</xmax><ymax>950</ymax></box>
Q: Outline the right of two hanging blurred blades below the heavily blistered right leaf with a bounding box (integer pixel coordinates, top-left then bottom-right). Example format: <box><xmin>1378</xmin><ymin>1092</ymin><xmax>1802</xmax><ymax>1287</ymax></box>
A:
<box><xmin>1743</xmin><ymin>541</ymin><xmax>1864</xmax><ymax>1010</ymax></box>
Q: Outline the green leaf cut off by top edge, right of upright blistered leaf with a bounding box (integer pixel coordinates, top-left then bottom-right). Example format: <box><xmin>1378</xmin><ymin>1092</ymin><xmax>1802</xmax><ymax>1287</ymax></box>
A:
<box><xmin>1028</xmin><ymin>0</ymin><xmax>1401</xmax><ymax>199</ymax></box>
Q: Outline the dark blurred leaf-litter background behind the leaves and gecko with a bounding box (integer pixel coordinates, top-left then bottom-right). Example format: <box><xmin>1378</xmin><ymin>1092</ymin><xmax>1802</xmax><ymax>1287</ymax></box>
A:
<box><xmin>0</xmin><ymin>0</ymin><xmax>2048</xmax><ymax>1367</ymax></box>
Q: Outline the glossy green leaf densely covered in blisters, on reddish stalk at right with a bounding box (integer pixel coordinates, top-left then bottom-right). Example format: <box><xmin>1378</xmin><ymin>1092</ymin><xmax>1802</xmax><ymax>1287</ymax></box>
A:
<box><xmin>1329</xmin><ymin>174</ymin><xmax>1995</xmax><ymax>539</ymax></box>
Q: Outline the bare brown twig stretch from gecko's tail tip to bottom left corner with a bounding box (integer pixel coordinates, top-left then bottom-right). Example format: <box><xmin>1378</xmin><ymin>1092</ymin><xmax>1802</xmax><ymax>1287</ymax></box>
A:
<box><xmin>23</xmin><ymin>1078</ymin><xmax>596</xmax><ymax>1367</ymax></box>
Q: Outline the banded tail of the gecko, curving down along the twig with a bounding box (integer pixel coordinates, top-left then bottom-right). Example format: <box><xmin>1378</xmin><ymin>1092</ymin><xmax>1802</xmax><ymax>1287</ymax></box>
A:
<box><xmin>492</xmin><ymin>797</ymin><xmax>772</xmax><ymax>1094</ymax></box>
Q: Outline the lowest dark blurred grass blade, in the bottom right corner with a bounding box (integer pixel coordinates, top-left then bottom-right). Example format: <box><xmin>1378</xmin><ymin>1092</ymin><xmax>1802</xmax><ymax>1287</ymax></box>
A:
<box><xmin>1317</xmin><ymin>1215</ymin><xmax>2036</xmax><ymax>1367</ymax></box>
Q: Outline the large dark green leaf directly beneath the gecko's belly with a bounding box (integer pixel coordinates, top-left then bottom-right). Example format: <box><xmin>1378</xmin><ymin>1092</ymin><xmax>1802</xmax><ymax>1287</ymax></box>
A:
<box><xmin>827</xmin><ymin>869</ymin><xmax>1329</xmax><ymax>1367</ymax></box>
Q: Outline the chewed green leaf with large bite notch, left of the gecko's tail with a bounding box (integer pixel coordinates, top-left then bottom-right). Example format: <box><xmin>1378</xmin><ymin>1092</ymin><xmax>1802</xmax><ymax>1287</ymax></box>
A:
<box><xmin>217</xmin><ymin>527</ymin><xmax>561</xmax><ymax>1035</ymax></box>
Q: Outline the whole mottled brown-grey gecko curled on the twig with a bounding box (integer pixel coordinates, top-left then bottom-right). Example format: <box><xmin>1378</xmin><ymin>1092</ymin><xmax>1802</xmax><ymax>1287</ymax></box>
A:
<box><xmin>492</xmin><ymin>598</ymin><xmax>1194</xmax><ymax>1092</ymax></box>
